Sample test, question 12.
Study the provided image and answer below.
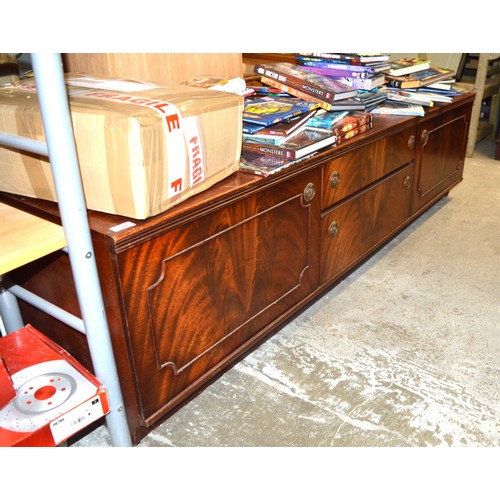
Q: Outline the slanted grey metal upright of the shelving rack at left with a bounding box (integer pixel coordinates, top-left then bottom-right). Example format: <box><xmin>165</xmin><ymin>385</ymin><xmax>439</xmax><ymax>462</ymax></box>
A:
<box><xmin>31</xmin><ymin>54</ymin><xmax>132</xmax><ymax>446</ymax></box>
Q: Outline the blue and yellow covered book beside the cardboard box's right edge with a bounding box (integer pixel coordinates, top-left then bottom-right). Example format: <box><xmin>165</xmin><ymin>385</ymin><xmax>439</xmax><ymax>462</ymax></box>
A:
<box><xmin>243</xmin><ymin>96</ymin><xmax>319</xmax><ymax>127</ymax></box>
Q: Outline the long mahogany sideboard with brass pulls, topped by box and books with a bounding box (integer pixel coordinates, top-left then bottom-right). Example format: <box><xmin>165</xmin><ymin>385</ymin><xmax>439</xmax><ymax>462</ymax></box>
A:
<box><xmin>0</xmin><ymin>93</ymin><xmax>474</xmax><ymax>443</ymax></box>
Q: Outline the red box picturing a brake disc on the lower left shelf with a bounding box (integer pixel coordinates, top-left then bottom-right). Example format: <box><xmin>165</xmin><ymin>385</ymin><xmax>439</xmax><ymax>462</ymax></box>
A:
<box><xmin>0</xmin><ymin>325</ymin><xmax>109</xmax><ymax>447</ymax></box>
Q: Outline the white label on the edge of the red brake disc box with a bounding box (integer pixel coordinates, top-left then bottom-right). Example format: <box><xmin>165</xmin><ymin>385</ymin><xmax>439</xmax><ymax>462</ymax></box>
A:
<box><xmin>50</xmin><ymin>395</ymin><xmax>104</xmax><ymax>444</ymax></box>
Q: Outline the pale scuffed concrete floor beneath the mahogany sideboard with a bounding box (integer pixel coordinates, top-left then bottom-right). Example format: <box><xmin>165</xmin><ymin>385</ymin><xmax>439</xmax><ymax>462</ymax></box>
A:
<box><xmin>72</xmin><ymin>140</ymin><xmax>500</xmax><ymax>447</ymax></box>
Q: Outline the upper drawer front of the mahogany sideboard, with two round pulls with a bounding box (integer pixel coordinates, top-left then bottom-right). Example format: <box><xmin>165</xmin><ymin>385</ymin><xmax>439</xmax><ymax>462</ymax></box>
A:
<box><xmin>322</xmin><ymin>127</ymin><xmax>416</xmax><ymax>209</ymax></box>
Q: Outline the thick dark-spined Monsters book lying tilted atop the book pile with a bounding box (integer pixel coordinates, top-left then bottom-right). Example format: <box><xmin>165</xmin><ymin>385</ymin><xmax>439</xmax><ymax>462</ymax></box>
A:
<box><xmin>254</xmin><ymin>63</ymin><xmax>357</xmax><ymax>103</ymax></box>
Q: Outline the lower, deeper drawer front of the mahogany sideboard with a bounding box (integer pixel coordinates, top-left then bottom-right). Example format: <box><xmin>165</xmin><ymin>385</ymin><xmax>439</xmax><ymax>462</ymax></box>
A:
<box><xmin>320</xmin><ymin>163</ymin><xmax>414</xmax><ymax>283</ymax></box>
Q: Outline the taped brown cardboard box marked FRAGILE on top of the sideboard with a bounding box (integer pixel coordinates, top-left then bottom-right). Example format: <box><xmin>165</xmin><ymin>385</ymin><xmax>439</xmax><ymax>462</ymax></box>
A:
<box><xmin>0</xmin><ymin>74</ymin><xmax>243</xmax><ymax>219</ymax></box>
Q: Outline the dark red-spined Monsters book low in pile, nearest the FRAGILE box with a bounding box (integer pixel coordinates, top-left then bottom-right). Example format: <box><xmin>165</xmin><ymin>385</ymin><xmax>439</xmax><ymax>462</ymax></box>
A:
<box><xmin>241</xmin><ymin>128</ymin><xmax>337</xmax><ymax>160</ymax></box>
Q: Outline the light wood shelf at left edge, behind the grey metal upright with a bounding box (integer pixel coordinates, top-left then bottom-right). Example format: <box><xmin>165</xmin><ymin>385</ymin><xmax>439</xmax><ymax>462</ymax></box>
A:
<box><xmin>0</xmin><ymin>203</ymin><xmax>66</xmax><ymax>275</ymax></box>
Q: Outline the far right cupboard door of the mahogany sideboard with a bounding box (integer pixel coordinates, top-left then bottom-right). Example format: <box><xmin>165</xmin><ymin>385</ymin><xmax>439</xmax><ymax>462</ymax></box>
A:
<box><xmin>412</xmin><ymin>105</ymin><xmax>471</xmax><ymax>214</ymax></box>
